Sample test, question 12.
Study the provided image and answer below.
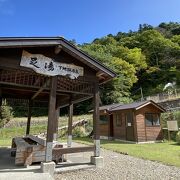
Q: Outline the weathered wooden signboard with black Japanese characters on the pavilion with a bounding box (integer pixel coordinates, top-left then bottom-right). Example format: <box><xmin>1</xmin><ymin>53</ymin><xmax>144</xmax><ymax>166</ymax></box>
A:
<box><xmin>20</xmin><ymin>50</ymin><xmax>84</xmax><ymax>79</ymax></box>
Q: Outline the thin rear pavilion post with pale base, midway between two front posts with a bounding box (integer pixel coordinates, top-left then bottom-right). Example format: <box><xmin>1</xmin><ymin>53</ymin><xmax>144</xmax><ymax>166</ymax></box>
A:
<box><xmin>67</xmin><ymin>97</ymin><xmax>73</xmax><ymax>147</ymax></box>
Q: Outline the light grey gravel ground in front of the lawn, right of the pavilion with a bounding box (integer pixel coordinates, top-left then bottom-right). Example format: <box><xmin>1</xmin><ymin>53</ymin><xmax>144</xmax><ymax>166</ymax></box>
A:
<box><xmin>55</xmin><ymin>149</ymin><xmax>180</xmax><ymax>180</ymax></box>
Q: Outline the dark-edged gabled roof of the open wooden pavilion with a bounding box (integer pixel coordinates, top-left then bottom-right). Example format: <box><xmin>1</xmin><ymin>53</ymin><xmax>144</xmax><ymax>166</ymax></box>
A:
<box><xmin>0</xmin><ymin>37</ymin><xmax>116</xmax><ymax>83</ymax></box>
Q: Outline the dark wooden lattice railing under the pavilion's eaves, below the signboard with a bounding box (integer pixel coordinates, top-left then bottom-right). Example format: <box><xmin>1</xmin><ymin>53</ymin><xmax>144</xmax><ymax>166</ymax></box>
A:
<box><xmin>0</xmin><ymin>70</ymin><xmax>93</xmax><ymax>94</ymax></box>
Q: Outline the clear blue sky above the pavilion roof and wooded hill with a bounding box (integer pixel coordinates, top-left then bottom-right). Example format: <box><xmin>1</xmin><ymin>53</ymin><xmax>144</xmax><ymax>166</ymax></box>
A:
<box><xmin>0</xmin><ymin>0</ymin><xmax>180</xmax><ymax>43</ymax></box>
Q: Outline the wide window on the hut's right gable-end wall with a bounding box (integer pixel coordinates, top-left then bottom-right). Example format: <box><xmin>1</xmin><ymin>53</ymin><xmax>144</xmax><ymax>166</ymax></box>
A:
<box><xmin>145</xmin><ymin>113</ymin><xmax>160</xmax><ymax>126</ymax></box>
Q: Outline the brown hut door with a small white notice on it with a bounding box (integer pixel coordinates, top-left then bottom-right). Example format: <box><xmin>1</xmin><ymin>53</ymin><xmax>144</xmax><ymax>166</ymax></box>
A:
<box><xmin>126</xmin><ymin>112</ymin><xmax>134</xmax><ymax>141</ymax></box>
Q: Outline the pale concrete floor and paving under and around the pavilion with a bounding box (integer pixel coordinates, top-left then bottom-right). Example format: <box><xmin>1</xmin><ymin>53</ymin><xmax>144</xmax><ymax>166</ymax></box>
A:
<box><xmin>0</xmin><ymin>143</ymin><xmax>94</xmax><ymax>180</ymax></box>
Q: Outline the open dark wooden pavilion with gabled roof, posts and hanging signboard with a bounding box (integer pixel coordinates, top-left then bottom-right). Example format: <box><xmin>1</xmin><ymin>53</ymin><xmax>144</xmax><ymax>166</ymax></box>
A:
<box><xmin>0</xmin><ymin>37</ymin><xmax>116</xmax><ymax>168</ymax></box>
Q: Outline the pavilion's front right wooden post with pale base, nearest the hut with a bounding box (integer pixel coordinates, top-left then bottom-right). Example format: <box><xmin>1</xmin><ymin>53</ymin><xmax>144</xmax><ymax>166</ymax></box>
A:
<box><xmin>93</xmin><ymin>82</ymin><xmax>100</xmax><ymax>157</ymax></box>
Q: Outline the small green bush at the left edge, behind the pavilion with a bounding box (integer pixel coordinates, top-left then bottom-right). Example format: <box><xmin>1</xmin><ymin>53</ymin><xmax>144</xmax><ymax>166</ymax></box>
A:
<box><xmin>0</xmin><ymin>106</ymin><xmax>12</xmax><ymax>128</ymax></box>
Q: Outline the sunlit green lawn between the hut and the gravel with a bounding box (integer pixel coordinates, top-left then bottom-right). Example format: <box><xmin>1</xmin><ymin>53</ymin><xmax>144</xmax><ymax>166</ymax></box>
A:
<box><xmin>76</xmin><ymin>138</ymin><xmax>180</xmax><ymax>167</ymax></box>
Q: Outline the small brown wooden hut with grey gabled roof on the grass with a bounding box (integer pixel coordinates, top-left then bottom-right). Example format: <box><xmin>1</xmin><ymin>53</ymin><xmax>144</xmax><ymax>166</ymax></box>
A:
<box><xmin>100</xmin><ymin>101</ymin><xmax>165</xmax><ymax>142</ymax></box>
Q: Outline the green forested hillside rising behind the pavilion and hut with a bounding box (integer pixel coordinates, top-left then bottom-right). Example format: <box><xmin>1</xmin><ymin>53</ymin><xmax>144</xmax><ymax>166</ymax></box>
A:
<box><xmin>79</xmin><ymin>22</ymin><xmax>180</xmax><ymax>104</ymax></box>
